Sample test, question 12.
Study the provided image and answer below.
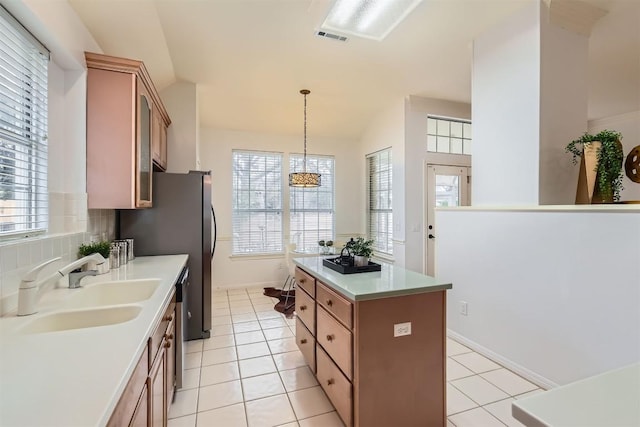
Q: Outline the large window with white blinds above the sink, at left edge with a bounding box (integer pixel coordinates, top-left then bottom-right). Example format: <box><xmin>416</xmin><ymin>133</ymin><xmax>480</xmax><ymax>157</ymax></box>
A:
<box><xmin>0</xmin><ymin>6</ymin><xmax>49</xmax><ymax>237</ymax></box>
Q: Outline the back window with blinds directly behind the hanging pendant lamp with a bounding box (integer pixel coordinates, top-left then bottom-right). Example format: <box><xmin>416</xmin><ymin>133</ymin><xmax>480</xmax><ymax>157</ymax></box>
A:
<box><xmin>289</xmin><ymin>154</ymin><xmax>335</xmax><ymax>251</ymax></box>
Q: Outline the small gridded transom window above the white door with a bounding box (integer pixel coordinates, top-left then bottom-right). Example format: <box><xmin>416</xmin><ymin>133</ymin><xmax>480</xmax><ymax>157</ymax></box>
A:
<box><xmin>427</xmin><ymin>116</ymin><xmax>472</xmax><ymax>154</ymax></box>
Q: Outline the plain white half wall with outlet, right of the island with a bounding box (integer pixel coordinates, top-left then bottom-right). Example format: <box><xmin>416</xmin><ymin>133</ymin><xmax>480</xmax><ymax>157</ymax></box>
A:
<box><xmin>436</xmin><ymin>206</ymin><xmax>640</xmax><ymax>386</ymax></box>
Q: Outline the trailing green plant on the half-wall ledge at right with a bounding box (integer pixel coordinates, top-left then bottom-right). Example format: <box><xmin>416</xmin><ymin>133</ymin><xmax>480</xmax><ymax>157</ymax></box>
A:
<box><xmin>565</xmin><ymin>129</ymin><xmax>624</xmax><ymax>203</ymax></box>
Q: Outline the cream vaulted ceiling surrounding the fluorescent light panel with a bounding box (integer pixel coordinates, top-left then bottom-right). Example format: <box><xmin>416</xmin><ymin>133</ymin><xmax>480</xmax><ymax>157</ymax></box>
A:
<box><xmin>69</xmin><ymin>0</ymin><xmax>640</xmax><ymax>138</ymax></box>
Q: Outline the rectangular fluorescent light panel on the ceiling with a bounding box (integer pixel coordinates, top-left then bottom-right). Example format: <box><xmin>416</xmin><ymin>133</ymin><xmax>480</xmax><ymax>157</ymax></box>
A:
<box><xmin>321</xmin><ymin>0</ymin><xmax>422</xmax><ymax>41</ymax></box>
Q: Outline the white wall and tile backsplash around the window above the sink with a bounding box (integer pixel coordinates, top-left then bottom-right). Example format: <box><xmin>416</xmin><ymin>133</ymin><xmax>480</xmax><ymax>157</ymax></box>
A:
<box><xmin>0</xmin><ymin>0</ymin><xmax>114</xmax><ymax>315</ymax></box>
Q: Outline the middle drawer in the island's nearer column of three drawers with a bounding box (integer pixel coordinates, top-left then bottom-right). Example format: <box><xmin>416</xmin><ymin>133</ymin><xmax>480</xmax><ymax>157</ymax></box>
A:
<box><xmin>316</xmin><ymin>306</ymin><xmax>353</xmax><ymax>380</ymax></box>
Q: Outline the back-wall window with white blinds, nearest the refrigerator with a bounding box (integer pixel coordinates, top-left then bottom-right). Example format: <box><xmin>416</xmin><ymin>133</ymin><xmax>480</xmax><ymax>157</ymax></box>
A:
<box><xmin>233</xmin><ymin>150</ymin><xmax>283</xmax><ymax>254</ymax></box>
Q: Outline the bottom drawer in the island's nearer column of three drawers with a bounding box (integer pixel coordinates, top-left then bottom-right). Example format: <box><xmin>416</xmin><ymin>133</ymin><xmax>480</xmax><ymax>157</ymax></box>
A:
<box><xmin>316</xmin><ymin>346</ymin><xmax>353</xmax><ymax>427</ymax></box>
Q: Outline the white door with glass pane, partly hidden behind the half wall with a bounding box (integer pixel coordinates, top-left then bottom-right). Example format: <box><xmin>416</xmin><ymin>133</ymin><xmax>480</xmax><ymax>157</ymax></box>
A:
<box><xmin>424</xmin><ymin>165</ymin><xmax>471</xmax><ymax>276</ymax></box>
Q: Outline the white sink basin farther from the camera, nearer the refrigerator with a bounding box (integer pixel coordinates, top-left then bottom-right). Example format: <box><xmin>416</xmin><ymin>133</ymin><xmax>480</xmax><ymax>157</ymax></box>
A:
<box><xmin>64</xmin><ymin>279</ymin><xmax>160</xmax><ymax>308</ymax></box>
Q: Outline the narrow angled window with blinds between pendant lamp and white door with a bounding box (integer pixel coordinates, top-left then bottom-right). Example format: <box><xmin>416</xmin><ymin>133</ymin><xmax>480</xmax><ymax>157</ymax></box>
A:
<box><xmin>367</xmin><ymin>148</ymin><xmax>393</xmax><ymax>255</ymax></box>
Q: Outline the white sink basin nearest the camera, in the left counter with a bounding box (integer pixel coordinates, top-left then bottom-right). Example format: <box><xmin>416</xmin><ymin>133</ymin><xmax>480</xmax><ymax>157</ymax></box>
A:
<box><xmin>22</xmin><ymin>305</ymin><xmax>142</xmax><ymax>334</ymax></box>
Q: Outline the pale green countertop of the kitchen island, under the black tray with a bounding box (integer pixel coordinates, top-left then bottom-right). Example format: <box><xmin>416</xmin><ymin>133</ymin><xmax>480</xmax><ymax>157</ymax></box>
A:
<box><xmin>293</xmin><ymin>257</ymin><xmax>452</xmax><ymax>301</ymax></box>
